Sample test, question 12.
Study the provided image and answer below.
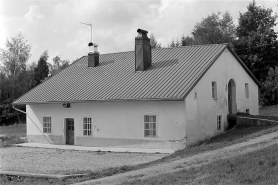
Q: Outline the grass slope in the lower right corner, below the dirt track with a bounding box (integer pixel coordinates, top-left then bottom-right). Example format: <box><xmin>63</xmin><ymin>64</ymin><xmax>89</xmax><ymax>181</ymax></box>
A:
<box><xmin>123</xmin><ymin>144</ymin><xmax>278</xmax><ymax>185</ymax></box>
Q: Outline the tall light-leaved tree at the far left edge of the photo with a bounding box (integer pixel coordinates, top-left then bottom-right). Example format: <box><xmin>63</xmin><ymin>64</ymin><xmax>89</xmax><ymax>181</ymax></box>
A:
<box><xmin>0</xmin><ymin>33</ymin><xmax>31</xmax><ymax>123</ymax></box>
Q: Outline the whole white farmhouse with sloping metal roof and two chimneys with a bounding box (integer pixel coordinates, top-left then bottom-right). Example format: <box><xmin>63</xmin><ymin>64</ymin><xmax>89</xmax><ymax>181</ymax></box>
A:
<box><xmin>13</xmin><ymin>29</ymin><xmax>259</xmax><ymax>149</ymax></box>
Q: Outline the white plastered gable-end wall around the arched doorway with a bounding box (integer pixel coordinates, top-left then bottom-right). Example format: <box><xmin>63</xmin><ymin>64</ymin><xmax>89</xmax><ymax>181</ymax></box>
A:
<box><xmin>185</xmin><ymin>50</ymin><xmax>259</xmax><ymax>145</ymax></box>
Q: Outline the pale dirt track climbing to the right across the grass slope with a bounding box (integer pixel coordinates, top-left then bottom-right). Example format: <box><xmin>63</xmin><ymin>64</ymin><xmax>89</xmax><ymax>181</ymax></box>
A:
<box><xmin>73</xmin><ymin>132</ymin><xmax>278</xmax><ymax>185</ymax></box>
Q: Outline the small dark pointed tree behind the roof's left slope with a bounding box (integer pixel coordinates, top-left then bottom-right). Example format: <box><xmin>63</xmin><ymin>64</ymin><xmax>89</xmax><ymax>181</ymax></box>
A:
<box><xmin>34</xmin><ymin>51</ymin><xmax>49</xmax><ymax>86</ymax></box>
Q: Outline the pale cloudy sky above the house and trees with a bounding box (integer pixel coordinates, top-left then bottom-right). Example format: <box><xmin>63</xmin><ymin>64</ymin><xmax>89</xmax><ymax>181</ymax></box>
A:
<box><xmin>0</xmin><ymin>0</ymin><xmax>278</xmax><ymax>64</ymax></box>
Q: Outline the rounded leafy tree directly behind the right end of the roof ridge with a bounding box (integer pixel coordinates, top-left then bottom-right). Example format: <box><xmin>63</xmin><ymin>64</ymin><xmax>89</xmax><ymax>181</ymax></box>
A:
<box><xmin>192</xmin><ymin>12</ymin><xmax>235</xmax><ymax>44</ymax></box>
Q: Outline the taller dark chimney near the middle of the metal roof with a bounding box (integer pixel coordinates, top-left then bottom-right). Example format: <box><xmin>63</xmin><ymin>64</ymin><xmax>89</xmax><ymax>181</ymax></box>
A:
<box><xmin>135</xmin><ymin>29</ymin><xmax>152</xmax><ymax>71</ymax></box>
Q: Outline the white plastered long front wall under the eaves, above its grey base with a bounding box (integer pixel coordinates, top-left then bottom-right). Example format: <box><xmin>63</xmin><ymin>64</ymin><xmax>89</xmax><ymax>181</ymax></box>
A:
<box><xmin>27</xmin><ymin>101</ymin><xmax>186</xmax><ymax>148</ymax></box>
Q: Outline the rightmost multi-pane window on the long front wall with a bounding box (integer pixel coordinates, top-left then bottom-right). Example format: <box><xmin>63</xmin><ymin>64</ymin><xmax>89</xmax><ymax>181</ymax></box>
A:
<box><xmin>144</xmin><ymin>115</ymin><xmax>156</xmax><ymax>137</ymax></box>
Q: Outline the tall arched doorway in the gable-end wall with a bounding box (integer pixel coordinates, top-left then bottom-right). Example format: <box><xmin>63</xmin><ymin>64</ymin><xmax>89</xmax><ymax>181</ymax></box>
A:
<box><xmin>228</xmin><ymin>79</ymin><xmax>237</xmax><ymax>114</ymax></box>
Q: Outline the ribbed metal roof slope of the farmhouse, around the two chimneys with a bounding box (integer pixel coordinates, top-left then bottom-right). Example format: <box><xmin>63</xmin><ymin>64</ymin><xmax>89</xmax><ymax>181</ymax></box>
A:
<box><xmin>14</xmin><ymin>44</ymin><xmax>230</xmax><ymax>104</ymax></box>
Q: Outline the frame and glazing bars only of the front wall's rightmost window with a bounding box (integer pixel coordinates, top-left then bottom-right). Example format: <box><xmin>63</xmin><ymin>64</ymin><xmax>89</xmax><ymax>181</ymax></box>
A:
<box><xmin>143</xmin><ymin>113</ymin><xmax>158</xmax><ymax>139</ymax></box>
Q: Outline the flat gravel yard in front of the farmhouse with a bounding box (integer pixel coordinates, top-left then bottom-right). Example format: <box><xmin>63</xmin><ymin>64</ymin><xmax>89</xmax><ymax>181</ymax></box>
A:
<box><xmin>0</xmin><ymin>147</ymin><xmax>166</xmax><ymax>174</ymax></box>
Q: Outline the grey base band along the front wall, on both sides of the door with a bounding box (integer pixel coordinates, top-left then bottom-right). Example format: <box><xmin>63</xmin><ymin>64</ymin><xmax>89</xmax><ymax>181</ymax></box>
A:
<box><xmin>27</xmin><ymin>135</ymin><xmax>186</xmax><ymax>150</ymax></box>
